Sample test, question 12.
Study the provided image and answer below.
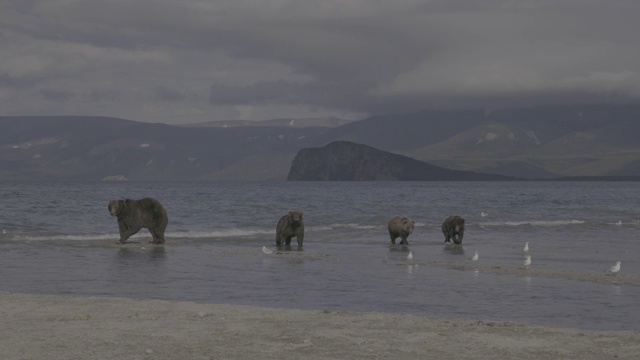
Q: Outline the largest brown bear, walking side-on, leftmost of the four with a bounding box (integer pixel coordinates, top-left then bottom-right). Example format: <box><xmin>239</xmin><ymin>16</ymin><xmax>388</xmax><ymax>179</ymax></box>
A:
<box><xmin>109</xmin><ymin>198</ymin><xmax>169</xmax><ymax>245</ymax></box>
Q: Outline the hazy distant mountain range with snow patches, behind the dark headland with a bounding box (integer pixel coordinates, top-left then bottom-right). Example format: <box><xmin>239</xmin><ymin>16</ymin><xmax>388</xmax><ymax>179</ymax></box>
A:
<box><xmin>0</xmin><ymin>105</ymin><xmax>640</xmax><ymax>180</ymax></box>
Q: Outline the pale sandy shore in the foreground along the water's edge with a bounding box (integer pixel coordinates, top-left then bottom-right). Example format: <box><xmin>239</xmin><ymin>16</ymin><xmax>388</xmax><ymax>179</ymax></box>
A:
<box><xmin>0</xmin><ymin>293</ymin><xmax>640</xmax><ymax>360</ymax></box>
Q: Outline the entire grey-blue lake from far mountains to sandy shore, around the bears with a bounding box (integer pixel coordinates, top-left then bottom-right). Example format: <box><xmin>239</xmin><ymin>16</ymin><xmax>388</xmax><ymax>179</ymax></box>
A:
<box><xmin>0</xmin><ymin>182</ymin><xmax>640</xmax><ymax>330</ymax></box>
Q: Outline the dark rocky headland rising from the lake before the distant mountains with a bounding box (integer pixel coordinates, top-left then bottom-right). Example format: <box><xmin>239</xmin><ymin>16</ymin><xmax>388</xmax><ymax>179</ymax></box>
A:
<box><xmin>287</xmin><ymin>141</ymin><xmax>515</xmax><ymax>181</ymax></box>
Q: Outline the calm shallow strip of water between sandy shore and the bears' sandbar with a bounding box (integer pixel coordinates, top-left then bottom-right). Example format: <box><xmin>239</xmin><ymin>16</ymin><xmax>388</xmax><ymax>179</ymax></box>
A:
<box><xmin>0</xmin><ymin>242</ymin><xmax>640</xmax><ymax>330</ymax></box>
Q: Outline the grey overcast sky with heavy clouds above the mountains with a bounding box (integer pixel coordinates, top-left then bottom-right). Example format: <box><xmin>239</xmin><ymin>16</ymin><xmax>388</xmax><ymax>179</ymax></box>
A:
<box><xmin>0</xmin><ymin>0</ymin><xmax>640</xmax><ymax>123</ymax></box>
